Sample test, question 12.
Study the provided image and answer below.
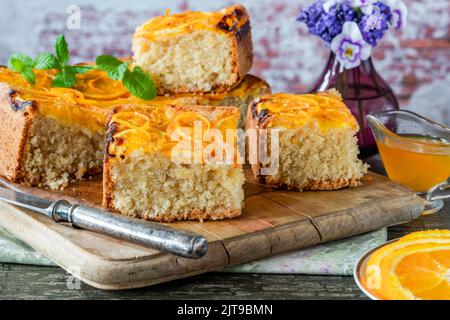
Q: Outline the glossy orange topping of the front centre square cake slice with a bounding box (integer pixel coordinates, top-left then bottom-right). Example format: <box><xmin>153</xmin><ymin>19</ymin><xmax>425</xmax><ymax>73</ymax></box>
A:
<box><xmin>108</xmin><ymin>106</ymin><xmax>240</xmax><ymax>160</ymax></box>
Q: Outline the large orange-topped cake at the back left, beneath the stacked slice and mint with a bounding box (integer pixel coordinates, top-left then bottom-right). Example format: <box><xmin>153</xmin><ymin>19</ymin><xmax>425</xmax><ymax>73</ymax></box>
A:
<box><xmin>0</xmin><ymin>67</ymin><xmax>270</xmax><ymax>189</ymax></box>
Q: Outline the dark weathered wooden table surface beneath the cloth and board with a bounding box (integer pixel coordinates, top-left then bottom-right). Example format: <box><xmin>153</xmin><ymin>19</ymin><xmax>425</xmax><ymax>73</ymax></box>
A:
<box><xmin>0</xmin><ymin>161</ymin><xmax>450</xmax><ymax>300</ymax></box>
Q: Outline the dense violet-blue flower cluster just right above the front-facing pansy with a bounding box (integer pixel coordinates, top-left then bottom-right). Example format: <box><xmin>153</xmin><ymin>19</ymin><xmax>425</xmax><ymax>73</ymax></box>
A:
<box><xmin>358</xmin><ymin>2</ymin><xmax>392</xmax><ymax>46</ymax></box>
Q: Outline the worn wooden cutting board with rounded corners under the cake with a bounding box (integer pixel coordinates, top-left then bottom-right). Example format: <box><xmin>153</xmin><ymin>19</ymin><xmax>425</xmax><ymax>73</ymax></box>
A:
<box><xmin>0</xmin><ymin>172</ymin><xmax>424</xmax><ymax>289</ymax></box>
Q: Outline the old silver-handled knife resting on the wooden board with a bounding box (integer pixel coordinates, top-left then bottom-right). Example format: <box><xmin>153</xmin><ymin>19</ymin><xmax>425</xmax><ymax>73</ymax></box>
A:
<box><xmin>0</xmin><ymin>187</ymin><xmax>208</xmax><ymax>259</ymax></box>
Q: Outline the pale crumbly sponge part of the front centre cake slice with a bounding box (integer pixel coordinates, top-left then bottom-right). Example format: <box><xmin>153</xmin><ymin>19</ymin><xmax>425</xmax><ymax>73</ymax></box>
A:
<box><xmin>104</xmin><ymin>152</ymin><xmax>244</xmax><ymax>222</ymax></box>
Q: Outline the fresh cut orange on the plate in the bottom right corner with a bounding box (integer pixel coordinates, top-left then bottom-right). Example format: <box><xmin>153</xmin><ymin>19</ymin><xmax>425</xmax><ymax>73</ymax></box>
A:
<box><xmin>363</xmin><ymin>230</ymin><xmax>450</xmax><ymax>299</ymax></box>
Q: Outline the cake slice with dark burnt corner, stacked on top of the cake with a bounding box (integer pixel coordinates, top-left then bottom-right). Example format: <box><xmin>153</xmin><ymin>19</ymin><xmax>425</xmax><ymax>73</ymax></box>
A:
<box><xmin>132</xmin><ymin>5</ymin><xmax>253</xmax><ymax>94</ymax></box>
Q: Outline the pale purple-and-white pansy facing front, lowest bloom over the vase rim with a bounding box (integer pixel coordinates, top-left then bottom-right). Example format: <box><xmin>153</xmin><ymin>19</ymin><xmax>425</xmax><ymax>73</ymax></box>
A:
<box><xmin>330</xmin><ymin>21</ymin><xmax>372</xmax><ymax>69</ymax></box>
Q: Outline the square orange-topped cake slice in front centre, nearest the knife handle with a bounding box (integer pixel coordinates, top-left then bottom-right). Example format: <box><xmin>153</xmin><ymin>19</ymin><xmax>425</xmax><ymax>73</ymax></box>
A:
<box><xmin>103</xmin><ymin>105</ymin><xmax>244</xmax><ymax>222</ymax></box>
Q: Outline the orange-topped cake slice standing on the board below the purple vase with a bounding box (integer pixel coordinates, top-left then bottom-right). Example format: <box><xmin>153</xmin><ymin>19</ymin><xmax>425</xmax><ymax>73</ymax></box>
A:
<box><xmin>247</xmin><ymin>91</ymin><xmax>367</xmax><ymax>191</ymax></box>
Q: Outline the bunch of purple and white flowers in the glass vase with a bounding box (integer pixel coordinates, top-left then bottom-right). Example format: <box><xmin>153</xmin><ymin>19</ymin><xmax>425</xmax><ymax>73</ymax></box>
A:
<box><xmin>297</xmin><ymin>0</ymin><xmax>407</xmax><ymax>68</ymax></box>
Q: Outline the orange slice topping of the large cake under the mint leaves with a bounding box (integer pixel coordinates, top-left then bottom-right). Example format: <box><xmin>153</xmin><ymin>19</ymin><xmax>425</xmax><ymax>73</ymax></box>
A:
<box><xmin>0</xmin><ymin>68</ymin><xmax>137</xmax><ymax>133</ymax></box>
